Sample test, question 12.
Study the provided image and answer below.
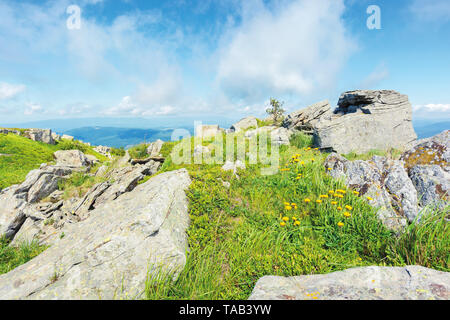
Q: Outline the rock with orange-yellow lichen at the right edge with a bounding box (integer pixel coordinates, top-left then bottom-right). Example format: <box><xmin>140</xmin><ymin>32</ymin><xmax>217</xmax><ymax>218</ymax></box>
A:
<box><xmin>401</xmin><ymin>130</ymin><xmax>450</xmax><ymax>172</ymax></box>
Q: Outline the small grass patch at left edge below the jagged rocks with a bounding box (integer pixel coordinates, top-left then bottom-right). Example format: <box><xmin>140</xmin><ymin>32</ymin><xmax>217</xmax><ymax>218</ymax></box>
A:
<box><xmin>0</xmin><ymin>238</ymin><xmax>46</xmax><ymax>274</ymax></box>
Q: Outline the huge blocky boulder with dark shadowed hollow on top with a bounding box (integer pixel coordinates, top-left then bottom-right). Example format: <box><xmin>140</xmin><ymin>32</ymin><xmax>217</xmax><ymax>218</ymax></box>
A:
<box><xmin>314</xmin><ymin>90</ymin><xmax>417</xmax><ymax>154</ymax></box>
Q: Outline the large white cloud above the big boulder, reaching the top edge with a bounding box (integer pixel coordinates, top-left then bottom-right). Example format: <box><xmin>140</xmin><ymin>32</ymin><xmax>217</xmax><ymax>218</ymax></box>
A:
<box><xmin>218</xmin><ymin>0</ymin><xmax>356</xmax><ymax>101</ymax></box>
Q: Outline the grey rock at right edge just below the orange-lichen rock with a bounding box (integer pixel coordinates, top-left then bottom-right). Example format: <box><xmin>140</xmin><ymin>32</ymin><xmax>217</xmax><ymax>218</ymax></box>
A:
<box><xmin>409</xmin><ymin>165</ymin><xmax>450</xmax><ymax>209</ymax></box>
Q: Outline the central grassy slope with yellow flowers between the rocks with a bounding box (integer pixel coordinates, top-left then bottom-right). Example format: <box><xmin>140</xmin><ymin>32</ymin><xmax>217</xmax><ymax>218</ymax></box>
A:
<box><xmin>146</xmin><ymin>131</ymin><xmax>450</xmax><ymax>299</ymax></box>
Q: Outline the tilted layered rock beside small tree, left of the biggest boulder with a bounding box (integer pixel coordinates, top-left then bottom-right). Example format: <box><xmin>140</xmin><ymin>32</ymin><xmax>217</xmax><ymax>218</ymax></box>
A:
<box><xmin>283</xmin><ymin>100</ymin><xmax>331</xmax><ymax>134</ymax></box>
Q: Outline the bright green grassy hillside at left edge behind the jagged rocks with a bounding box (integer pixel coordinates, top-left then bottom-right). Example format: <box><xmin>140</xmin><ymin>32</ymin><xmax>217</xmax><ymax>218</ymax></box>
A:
<box><xmin>0</xmin><ymin>134</ymin><xmax>108</xmax><ymax>189</ymax></box>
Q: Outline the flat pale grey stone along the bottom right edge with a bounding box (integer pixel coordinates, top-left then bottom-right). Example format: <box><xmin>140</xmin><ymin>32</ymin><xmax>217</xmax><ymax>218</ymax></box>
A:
<box><xmin>249</xmin><ymin>266</ymin><xmax>450</xmax><ymax>300</ymax></box>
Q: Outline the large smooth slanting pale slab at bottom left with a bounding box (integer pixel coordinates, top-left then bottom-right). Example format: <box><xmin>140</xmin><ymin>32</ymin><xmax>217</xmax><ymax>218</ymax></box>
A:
<box><xmin>0</xmin><ymin>169</ymin><xmax>191</xmax><ymax>300</ymax></box>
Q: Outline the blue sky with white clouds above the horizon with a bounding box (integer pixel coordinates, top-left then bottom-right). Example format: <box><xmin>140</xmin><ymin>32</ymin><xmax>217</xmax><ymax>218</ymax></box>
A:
<box><xmin>0</xmin><ymin>0</ymin><xmax>450</xmax><ymax>127</ymax></box>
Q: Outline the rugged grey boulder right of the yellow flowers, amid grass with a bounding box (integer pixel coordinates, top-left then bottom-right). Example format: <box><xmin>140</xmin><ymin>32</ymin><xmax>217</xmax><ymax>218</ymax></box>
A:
<box><xmin>324</xmin><ymin>153</ymin><xmax>419</xmax><ymax>231</ymax></box>
